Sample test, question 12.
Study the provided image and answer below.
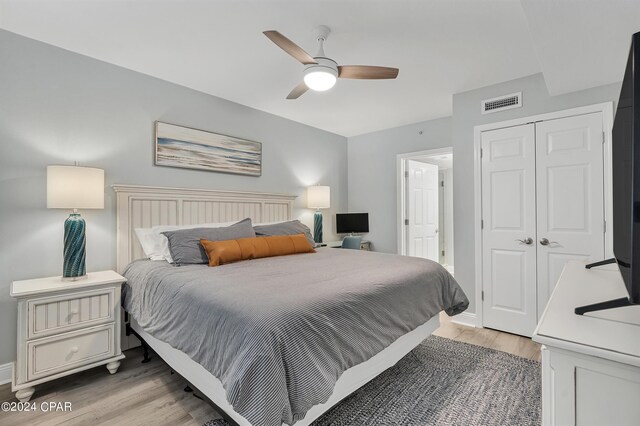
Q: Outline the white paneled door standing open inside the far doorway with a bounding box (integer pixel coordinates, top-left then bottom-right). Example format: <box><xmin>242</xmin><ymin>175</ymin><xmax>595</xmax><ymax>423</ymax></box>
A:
<box><xmin>407</xmin><ymin>160</ymin><xmax>439</xmax><ymax>262</ymax></box>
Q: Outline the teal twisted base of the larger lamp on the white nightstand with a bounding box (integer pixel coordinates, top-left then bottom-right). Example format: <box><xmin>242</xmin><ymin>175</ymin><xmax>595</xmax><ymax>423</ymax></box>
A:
<box><xmin>62</xmin><ymin>213</ymin><xmax>87</xmax><ymax>281</ymax></box>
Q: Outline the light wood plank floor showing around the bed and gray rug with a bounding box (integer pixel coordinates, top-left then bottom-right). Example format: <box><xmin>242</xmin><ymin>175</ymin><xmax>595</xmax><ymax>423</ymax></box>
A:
<box><xmin>0</xmin><ymin>314</ymin><xmax>540</xmax><ymax>426</ymax></box>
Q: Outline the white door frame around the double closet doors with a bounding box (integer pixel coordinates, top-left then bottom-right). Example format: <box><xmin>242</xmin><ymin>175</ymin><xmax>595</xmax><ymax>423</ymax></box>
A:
<box><xmin>473</xmin><ymin>102</ymin><xmax>613</xmax><ymax>327</ymax></box>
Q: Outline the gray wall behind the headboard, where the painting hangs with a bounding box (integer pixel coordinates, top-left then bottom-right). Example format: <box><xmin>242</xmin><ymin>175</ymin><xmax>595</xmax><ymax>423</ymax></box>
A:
<box><xmin>0</xmin><ymin>31</ymin><xmax>347</xmax><ymax>364</ymax></box>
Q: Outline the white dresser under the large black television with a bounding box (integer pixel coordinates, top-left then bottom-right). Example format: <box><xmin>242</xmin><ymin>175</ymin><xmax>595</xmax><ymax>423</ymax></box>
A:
<box><xmin>533</xmin><ymin>262</ymin><xmax>640</xmax><ymax>426</ymax></box>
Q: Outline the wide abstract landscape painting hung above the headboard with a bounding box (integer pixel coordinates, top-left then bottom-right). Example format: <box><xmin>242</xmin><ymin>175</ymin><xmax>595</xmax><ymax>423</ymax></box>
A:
<box><xmin>156</xmin><ymin>121</ymin><xmax>262</xmax><ymax>176</ymax></box>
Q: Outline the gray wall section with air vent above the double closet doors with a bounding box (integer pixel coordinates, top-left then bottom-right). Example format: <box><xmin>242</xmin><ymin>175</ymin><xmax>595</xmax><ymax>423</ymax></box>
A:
<box><xmin>452</xmin><ymin>74</ymin><xmax>620</xmax><ymax>312</ymax></box>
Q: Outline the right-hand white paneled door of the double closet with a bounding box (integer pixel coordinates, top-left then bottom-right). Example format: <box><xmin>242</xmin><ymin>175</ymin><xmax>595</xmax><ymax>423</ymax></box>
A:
<box><xmin>536</xmin><ymin>113</ymin><xmax>604</xmax><ymax>315</ymax></box>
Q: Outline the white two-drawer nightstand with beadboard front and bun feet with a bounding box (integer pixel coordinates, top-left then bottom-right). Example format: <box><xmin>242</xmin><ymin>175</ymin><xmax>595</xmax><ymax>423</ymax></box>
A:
<box><xmin>11</xmin><ymin>271</ymin><xmax>126</xmax><ymax>402</ymax></box>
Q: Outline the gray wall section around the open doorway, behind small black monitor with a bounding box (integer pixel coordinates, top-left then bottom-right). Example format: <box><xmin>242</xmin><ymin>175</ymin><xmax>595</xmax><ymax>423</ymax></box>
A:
<box><xmin>348</xmin><ymin>117</ymin><xmax>455</xmax><ymax>253</ymax></box>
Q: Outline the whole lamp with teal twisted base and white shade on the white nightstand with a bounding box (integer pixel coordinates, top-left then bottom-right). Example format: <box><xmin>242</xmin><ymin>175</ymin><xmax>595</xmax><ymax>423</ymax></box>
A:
<box><xmin>47</xmin><ymin>166</ymin><xmax>104</xmax><ymax>281</ymax></box>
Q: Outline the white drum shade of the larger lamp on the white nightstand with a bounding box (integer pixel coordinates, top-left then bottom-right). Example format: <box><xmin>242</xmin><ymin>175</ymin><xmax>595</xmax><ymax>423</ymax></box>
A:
<box><xmin>47</xmin><ymin>166</ymin><xmax>104</xmax><ymax>209</ymax></box>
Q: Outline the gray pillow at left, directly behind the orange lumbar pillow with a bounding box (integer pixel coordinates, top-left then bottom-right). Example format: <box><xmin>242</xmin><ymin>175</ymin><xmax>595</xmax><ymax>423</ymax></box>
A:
<box><xmin>162</xmin><ymin>218</ymin><xmax>256</xmax><ymax>265</ymax></box>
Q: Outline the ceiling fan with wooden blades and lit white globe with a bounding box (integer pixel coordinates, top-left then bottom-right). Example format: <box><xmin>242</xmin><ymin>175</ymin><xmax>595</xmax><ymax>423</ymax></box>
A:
<box><xmin>263</xmin><ymin>25</ymin><xmax>399</xmax><ymax>99</ymax></box>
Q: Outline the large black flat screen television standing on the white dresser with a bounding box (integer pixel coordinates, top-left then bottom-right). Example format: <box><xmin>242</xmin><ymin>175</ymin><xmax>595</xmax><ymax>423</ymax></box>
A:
<box><xmin>575</xmin><ymin>32</ymin><xmax>640</xmax><ymax>315</ymax></box>
